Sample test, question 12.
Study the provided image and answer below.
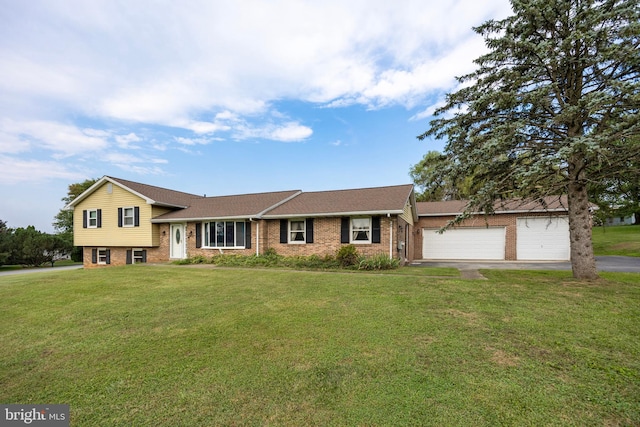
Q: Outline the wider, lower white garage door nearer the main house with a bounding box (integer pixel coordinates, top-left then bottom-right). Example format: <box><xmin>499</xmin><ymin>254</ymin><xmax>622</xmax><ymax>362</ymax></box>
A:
<box><xmin>422</xmin><ymin>227</ymin><xmax>505</xmax><ymax>260</ymax></box>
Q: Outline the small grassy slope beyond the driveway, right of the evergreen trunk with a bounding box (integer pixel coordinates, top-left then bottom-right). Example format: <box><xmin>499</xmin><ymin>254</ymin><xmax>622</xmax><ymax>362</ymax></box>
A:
<box><xmin>592</xmin><ymin>225</ymin><xmax>640</xmax><ymax>257</ymax></box>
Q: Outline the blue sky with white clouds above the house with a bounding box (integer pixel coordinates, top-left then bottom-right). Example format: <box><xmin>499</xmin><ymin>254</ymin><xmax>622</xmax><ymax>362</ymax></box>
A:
<box><xmin>0</xmin><ymin>0</ymin><xmax>510</xmax><ymax>232</ymax></box>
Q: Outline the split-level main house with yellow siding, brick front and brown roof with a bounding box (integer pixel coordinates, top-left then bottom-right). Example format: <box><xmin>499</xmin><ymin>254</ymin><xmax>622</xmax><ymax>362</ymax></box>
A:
<box><xmin>67</xmin><ymin>176</ymin><xmax>418</xmax><ymax>267</ymax></box>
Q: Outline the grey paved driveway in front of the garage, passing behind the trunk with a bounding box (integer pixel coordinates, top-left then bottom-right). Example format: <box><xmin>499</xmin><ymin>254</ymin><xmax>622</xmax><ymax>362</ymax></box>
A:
<box><xmin>411</xmin><ymin>256</ymin><xmax>640</xmax><ymax>273</ymax></box>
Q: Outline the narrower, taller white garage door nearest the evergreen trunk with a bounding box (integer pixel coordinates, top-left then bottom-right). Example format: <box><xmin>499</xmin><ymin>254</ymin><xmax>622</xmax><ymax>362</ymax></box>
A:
<box><xmin>516</xmin><ymin>217</ymin><xmax>570</xmax><ymax>261</ymax></box>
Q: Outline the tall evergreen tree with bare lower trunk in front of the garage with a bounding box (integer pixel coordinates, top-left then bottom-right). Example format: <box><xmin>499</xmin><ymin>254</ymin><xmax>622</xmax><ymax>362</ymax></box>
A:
<box><xmin>418</xmin><ymin>0</ymin><xmax>640</xmax><ymax>279</ymax></box>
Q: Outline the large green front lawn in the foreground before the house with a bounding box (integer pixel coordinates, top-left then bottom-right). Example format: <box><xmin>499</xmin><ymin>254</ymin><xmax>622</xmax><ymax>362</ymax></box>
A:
<box><xmin>0</xmin><ymin>266</ymin><xmax>640</xmax><ymax>426</ymax></box>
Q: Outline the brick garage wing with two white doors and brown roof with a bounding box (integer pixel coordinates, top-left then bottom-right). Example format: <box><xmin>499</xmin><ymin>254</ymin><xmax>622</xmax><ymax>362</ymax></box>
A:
<box><xmin>414</xmin><ymin>196</ymin><xmax>570</xmax><ymax>261</ymax></box>
